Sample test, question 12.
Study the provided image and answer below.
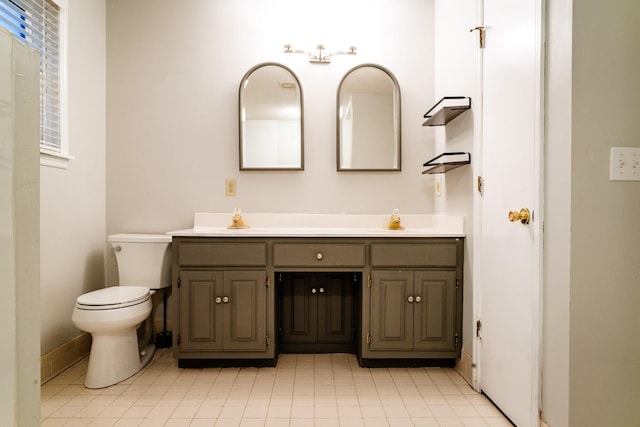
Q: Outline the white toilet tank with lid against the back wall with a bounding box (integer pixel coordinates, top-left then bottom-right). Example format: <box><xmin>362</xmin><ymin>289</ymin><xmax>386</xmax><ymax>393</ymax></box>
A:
<box><xmin>107</xmin><ymin>234</ymin><xmax>171</xmax><ymax>289</ymax></box>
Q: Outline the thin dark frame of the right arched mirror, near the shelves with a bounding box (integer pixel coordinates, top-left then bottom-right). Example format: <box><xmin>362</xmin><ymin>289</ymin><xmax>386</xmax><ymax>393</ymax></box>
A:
<box><xmin>336</xmin><ymin>63</ymin><xmax>402</xmax><ymax>172</ymax></box>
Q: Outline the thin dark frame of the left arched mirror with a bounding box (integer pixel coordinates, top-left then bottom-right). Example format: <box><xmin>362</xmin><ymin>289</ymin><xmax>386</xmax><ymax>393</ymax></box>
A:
<box><xmin>238</xmin><ymin>62</ymin><xmax>304</xmax><ymax>171</ymax></box>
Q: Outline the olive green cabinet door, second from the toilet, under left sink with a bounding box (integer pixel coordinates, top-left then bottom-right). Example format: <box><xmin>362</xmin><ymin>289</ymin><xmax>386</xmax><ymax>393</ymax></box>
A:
<box><xmin>222</xmin><ymin>271</ymin><xmax>267</xmax><ymax>351</ymax></box>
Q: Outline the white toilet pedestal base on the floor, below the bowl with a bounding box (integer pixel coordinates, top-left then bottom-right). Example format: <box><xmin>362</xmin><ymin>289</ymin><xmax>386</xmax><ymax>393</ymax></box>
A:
<box><xmin>84</xmin><ymin>327</ymin><xmax>155</xmax><ymax>388</ymax></box>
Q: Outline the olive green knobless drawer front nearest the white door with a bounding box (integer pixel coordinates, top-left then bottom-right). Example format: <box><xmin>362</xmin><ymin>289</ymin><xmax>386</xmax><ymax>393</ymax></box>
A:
<box><xmin>371</xmin><ymin>243</ymin><xmax>457</xmax><ymax>267</ymax></box>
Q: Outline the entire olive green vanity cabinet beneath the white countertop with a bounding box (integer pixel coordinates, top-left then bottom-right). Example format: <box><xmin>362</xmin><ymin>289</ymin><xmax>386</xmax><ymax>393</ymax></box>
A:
<box><xmin>172</xmin><ymin>232</ymin><xmax>464</xmax><ymax>367</ymax></box>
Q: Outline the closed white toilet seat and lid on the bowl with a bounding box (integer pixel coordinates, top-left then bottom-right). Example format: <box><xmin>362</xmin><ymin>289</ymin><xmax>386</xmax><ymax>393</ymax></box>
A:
<box><xmin>76</xmin><ymin>286</ymin><xmax>151</xmax><ymax>310</ymax></box>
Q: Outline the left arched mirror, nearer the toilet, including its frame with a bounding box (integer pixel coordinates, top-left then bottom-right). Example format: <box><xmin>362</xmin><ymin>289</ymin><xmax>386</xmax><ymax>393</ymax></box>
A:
<box><xmin>240</xmin><ymin>63</ymin><xmax>304</xmax><ymax>170</ymax></box>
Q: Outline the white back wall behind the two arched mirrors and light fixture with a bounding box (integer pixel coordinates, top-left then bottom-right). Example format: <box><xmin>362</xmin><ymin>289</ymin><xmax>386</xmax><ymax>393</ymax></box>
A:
<box><xmin>107</xmin><ymin>0</ymin><xmax>434</xmax><ymax>233</ymax></box>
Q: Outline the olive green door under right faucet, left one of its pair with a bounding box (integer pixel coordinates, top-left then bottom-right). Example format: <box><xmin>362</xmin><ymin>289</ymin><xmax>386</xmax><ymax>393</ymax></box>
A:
<box><xmin>369</xmin><ymin>270</ymin><xmax>413</xmax><ymax>351</ymax></box>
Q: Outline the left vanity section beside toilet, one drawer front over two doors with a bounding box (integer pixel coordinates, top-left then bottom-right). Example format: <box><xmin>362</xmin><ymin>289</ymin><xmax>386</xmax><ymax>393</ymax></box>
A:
<box><xmin>173</xmin><ymin>238</ymin><xmax>275</xmax><ymax>367</ymax></box>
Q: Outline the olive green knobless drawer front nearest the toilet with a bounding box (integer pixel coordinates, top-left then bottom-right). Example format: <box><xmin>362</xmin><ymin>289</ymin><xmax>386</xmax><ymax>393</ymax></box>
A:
<box><xmin>178</xmin><ymin>242</ymin><xmax>267</xmax><ymax>267</ymax></box>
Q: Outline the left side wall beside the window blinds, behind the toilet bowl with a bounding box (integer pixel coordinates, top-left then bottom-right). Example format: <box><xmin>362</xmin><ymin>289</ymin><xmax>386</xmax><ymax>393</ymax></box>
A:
<box><xmin>40</xmin><ymin>0</ymin><xmax>106</xmax><ymax>354</ymax></box>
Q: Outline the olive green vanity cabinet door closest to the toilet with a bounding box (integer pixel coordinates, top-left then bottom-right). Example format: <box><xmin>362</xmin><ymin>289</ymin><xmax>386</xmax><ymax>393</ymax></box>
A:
<box><xmin>179</xmin><ymin>271</ymin><xmax>224</xmax><ymax>352</ymax></box>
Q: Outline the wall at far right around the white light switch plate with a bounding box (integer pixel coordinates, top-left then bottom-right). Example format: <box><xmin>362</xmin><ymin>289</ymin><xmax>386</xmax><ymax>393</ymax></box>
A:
<box><xmin>569</xmin><ymin>0</ymin><xmax>640</xmax><ymax>426</ymax></box>
